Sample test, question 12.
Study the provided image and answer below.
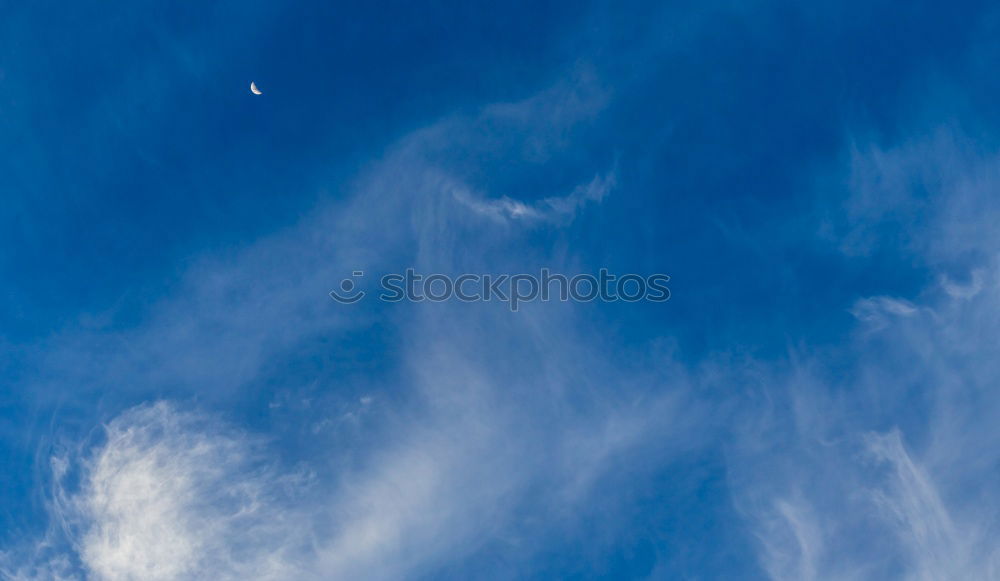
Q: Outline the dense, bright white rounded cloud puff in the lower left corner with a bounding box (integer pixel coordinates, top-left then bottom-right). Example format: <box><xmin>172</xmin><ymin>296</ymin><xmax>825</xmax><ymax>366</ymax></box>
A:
<box><xmin>57</xmin><ymin>402</ymin><xmax>307</xmax><ymax>581</ymax></box>
